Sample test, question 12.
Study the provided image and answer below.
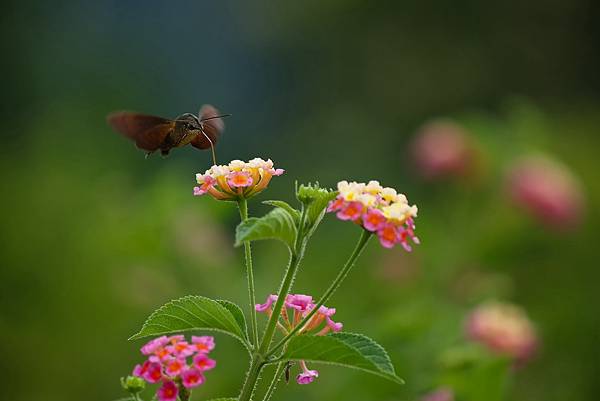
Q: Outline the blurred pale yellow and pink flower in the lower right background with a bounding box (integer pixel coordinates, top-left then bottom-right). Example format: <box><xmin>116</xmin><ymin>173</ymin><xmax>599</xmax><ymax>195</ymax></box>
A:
<box><xmin>466</xmin><ymin>302</ymin><xmax>538</xmax><ymax>362</ymax></box>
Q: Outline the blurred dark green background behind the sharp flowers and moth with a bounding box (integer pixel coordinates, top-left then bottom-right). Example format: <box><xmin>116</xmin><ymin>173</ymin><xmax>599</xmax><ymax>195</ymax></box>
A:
<box><xmin>0</xmin><ymin>0</ymin><xmax>600</xmax><ymax>401</ymax></box>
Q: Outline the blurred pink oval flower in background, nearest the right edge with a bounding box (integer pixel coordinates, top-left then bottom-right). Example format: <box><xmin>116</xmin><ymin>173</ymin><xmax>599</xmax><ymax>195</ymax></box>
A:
<box><xmin>507</xmin><ymin>155</ymin><xmax>584</xmax><ymax>228</ymax></box>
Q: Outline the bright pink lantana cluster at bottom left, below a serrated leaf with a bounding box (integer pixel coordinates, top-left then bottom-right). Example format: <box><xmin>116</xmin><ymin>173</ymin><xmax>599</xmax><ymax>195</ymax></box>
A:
<box><xmin>133</xmin><ymin>335</ymin><xmax>216</xmax><ymax>401</ymax></box>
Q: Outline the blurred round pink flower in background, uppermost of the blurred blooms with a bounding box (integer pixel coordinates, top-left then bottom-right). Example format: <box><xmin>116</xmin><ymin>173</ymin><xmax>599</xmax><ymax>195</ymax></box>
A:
<box><xmin>412</xmin><ymin>120</ymin><xmax>473</xmax><ymax>179</ymax></box>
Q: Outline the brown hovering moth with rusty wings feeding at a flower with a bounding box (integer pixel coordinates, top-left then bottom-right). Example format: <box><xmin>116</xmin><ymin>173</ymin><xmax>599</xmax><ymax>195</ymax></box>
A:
<box><xmin>107</xmin><ymin>104</ymin><xmax>230</xmax><ymax>161</ymax></box>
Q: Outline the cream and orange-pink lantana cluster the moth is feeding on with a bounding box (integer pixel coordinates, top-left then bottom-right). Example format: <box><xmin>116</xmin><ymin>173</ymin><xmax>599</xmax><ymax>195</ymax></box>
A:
<box><xmin>194</xmin><ymin>157</ymin><xmax>284</xmax><ymax>200</ymax></box>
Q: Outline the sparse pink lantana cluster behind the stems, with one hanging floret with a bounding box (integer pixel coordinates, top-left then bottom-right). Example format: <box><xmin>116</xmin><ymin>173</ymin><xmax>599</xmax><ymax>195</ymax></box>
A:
<box><xmin>256</xmin><ymin>294</ymin><xmax>343</xmax><ymax>384</ymax></box>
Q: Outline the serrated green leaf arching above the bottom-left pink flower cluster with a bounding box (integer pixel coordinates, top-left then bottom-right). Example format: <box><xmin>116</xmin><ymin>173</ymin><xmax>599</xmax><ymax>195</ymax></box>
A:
<box><xmin>130</xmin><ymin>295</ymin><xmax>248</xmax><ymax>347</ymax></box>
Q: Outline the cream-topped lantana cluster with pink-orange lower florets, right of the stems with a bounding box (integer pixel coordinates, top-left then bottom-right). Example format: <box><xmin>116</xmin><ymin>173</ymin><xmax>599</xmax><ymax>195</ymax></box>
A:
<box><xmin>327</xmin><ymin>181</ymin><xmax>419</xmax><ymax>248</ymax></box>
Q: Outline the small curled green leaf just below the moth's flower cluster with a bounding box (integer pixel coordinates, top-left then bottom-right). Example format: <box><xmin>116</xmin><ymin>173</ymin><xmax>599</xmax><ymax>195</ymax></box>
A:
<box><xmin>235</xmin><ymin>208</ymin><xmax>296</xmax><ymax>248</ymax></box>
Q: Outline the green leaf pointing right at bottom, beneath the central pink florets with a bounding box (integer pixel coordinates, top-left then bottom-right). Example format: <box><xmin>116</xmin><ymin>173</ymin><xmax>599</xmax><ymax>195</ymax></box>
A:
<box><xmin>283</xmin><ymin>333</ymin><xmax>404</xmax><ymax>384</ymax></box>
